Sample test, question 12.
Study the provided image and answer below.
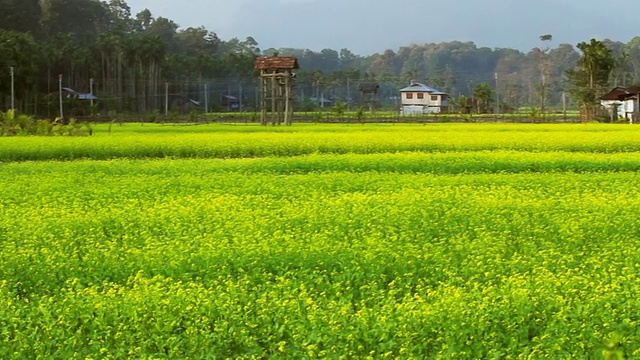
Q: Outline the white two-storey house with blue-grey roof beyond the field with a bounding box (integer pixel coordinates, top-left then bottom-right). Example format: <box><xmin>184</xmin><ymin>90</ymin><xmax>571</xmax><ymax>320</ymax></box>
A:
<box><xmin>400</xmin><ymin>81</ymin><xmax>449</xmax><ymax>115</ymax></box>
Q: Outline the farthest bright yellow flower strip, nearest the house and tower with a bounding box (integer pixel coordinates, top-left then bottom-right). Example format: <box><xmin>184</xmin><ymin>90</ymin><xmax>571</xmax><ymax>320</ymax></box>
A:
<box><xmin>0</xmin><ymin>124</ymin><xmax>640</xmax><ymax>162</ymax></box>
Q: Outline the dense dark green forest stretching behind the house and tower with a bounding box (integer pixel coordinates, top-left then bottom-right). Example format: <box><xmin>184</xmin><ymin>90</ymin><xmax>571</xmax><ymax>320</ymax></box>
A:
<box><xmin>0</xmin><ymin>0</ymin><xmax>640</xmax><ymax>117</ymax></box>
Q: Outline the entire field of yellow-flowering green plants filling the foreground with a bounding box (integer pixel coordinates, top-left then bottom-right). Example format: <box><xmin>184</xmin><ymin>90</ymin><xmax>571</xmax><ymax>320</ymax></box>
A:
<box><xmin>0</xmin><ymin>124</ymin><xmax>640</xmax><ymax>359</ymax></box>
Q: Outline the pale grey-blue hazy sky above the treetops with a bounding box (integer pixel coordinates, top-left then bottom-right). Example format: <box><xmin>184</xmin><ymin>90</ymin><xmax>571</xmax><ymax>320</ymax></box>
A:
<box><xmin>127</xmin><ymin>0</ymin><xmax>640</xmax><ymax>55</ymax></box>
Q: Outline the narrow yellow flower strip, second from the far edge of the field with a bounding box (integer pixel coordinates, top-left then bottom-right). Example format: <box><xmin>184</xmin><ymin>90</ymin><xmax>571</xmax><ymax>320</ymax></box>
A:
<box><xmin>0</xmin><ymin>150</ymin><xmax>640</xmax><ymax>179</ymax></box>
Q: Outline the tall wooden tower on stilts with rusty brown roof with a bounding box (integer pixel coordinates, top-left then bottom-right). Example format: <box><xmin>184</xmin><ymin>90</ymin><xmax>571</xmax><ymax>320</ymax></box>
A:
<box><xmin>255</xmin><ymin>56</ymin><xmax>299</xmax><ymax>125</ymax></box>
